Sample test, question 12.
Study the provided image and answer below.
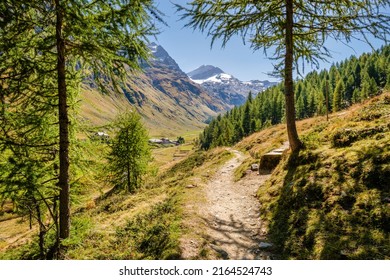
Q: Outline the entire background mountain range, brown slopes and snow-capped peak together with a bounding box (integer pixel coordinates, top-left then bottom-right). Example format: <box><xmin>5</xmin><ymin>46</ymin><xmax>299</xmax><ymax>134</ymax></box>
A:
<box><xmin>80</xmin><ymin>43</ymin><xmax>272</xmax><ymax>136</ymax></box>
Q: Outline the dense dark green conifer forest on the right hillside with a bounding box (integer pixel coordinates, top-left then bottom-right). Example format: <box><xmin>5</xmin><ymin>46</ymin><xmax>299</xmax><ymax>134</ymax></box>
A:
<box><xmin>200</xmin><ymin>46</ymin><xmax>390</xmax><ymax>150</ymax></box>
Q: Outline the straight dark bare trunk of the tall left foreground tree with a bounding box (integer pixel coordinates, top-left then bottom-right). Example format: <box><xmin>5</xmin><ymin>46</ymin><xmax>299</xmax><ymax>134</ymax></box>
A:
<box><xmin>55</xmin><ymin>0</ymin><xmax>70</xmax><ymax>240</ymax></box>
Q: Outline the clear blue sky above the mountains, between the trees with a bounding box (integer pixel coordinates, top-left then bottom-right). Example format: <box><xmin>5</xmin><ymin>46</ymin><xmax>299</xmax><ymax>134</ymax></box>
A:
<box><xmin>155</xmin><ymin>0</ymin><xmax>382</xmax><ymax>81</ymax></box>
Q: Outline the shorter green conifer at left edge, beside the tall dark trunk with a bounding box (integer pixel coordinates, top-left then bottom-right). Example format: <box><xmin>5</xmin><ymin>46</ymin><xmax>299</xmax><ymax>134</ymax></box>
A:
<box><xmin>0</xmin><ymin>96</ymin><xmax>58</xmax><ymax>259</ymax></box>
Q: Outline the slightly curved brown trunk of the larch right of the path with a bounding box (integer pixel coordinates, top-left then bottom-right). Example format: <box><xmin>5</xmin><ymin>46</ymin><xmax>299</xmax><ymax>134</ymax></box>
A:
<box><xmin>284</xmin><ymin>0</ymin><xmax>302</xmax><ymax>153</ymax></box>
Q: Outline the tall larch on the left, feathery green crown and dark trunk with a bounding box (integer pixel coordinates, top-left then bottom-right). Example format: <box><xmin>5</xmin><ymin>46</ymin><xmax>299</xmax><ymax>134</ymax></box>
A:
<box><xmin>0</xmin><ymin>0</ymin><xmax>162</xmax><ymax>250</ymax></box>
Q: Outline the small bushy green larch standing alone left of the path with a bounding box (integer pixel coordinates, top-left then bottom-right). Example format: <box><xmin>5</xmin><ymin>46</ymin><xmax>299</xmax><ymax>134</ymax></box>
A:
<box><xmin>108</xmin><ymin>112</ymin><xmax>151</xmax><ymax>192</ymax></box>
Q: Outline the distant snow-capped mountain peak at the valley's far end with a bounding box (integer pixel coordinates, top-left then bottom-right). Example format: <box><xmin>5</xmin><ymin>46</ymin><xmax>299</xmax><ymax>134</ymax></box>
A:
<box><xmin>187</xmin><ymin>65</ymin><xmax>276</xmax><ymax>105</ymax></box>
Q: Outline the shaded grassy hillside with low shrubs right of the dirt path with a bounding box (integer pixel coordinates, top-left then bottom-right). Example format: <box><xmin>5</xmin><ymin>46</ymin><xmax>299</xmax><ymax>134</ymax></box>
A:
<box><xmin>251</xmin><ymin>93</ymin><xmax>390</xmax><ymax>259</ymax></box>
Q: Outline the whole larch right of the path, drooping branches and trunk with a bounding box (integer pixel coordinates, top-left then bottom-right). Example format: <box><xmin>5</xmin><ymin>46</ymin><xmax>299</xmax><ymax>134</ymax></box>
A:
<box><xmin>177</xmin><ymin>0</ymin><xmax>390</xmax><ymax>152</ymax></box>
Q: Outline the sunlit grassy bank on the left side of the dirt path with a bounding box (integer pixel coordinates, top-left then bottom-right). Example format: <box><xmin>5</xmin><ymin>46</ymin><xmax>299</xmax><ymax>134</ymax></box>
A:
<box><xmin>59</xmin><ymin>150</ymin><xmax>230</xmax><ymax>259</ymax></box>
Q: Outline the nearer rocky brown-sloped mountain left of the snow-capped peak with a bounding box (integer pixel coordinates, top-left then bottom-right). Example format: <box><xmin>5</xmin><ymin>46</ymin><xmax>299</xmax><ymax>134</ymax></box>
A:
<box><xmin>81</xmin><ymin>44</ymin><xmax>231</xmax><ymax>136</ymax></box>
